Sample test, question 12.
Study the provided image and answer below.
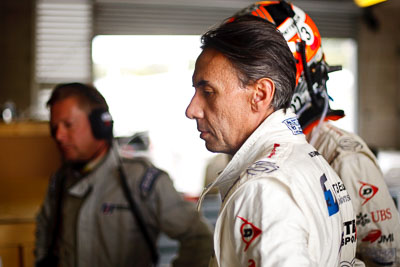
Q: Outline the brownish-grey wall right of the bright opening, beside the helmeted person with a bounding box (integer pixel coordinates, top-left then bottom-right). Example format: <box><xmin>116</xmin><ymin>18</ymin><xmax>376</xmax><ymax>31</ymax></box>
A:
<box><xmin>358</xmin><ymin>0</ymin><xmax>400</xmax><ymax>150</ymax></box>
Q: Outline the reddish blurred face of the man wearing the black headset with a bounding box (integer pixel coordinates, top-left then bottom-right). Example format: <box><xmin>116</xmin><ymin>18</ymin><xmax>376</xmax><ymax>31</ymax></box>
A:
<box><xmin>50</xmin><ymin>97</ymin><xmax>106</xmax><ymax>162</ymax></box>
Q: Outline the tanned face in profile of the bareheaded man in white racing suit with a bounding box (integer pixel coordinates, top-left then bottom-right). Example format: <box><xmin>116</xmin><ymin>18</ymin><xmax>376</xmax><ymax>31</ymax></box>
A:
<box><xmin>186</xmin><ymin>49</ymin><xmax>254</xmax><ymax>155</ymax></box>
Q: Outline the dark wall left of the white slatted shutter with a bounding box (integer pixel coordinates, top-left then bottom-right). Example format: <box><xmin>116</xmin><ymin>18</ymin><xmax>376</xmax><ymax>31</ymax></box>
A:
<box><xmin>0</xmin><ymin>0</ymin><xmax>35</xmax><ymax>112</ymax></box>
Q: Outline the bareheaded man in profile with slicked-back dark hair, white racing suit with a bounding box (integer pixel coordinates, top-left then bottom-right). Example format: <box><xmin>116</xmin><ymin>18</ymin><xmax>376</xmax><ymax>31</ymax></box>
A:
<box><xmin>186</xmin><ymin>16</ymin><xmax>356</xmax><ymax>267</ymax></box>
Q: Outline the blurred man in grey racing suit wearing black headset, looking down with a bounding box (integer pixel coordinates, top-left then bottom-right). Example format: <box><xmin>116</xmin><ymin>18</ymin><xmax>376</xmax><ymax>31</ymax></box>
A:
<box><xmin>35</xmin><ymin>83</ymin><xmax>212</xmax><ymax>267</ymax></box>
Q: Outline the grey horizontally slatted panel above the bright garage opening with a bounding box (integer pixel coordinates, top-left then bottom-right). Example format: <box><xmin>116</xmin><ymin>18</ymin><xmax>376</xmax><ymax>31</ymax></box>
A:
<box><xmin>94</xmin><ymin>0</ymin><xmax>361</xmax><ymax>38</ymax></box>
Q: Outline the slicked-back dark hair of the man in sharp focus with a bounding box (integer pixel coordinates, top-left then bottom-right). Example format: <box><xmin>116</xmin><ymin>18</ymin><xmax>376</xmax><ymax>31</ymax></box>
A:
<box><xmin>201</xmin><ymin>15</ymin><xmax>296</xmax><ymax>110</ymax></box>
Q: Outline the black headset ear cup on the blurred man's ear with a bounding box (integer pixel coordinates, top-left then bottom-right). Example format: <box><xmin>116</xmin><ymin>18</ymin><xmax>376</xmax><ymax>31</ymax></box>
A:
<box><xmin>89</xmin><ymin>108</ymin><xmax>114</xmax><ymax>140</ymax></box>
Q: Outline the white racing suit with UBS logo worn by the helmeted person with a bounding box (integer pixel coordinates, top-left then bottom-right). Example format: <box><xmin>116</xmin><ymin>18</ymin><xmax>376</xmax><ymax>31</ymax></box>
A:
<box><xmin>307</xmin><ymin>122</ymin><xmax>400</xmax><ymax>267</ymax></box>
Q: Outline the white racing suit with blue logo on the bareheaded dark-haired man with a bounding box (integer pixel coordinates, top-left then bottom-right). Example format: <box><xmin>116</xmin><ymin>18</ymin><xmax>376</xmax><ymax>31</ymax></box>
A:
<box><xmin>199</xmin><ymin>110</ymin><xmax>356</xmax><ymax>267</ymax></box>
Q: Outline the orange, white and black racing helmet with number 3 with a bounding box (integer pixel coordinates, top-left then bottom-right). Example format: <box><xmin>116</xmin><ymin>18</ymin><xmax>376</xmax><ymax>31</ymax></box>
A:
<box><xmin>232</xmin><ymin>1</ymin><xmax>344</xmax><ymax>134</ymax></box>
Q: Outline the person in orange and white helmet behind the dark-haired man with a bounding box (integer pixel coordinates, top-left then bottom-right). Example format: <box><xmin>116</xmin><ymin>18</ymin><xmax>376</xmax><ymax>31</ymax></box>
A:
<box><xmin>237</xmin><ymin>1</ymin><xmax>400</xmax><ymax>266</ymax></box>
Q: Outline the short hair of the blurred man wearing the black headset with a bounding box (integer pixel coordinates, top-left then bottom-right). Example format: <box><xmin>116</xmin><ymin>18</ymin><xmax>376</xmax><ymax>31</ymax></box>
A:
<box><xmin>47</xmin><ymin>83</ymin><xmax>108</xmax><ymax>114</ymax></box>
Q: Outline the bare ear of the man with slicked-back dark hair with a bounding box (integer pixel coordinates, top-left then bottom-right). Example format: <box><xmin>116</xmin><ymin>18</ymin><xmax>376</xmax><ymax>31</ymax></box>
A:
<box><xmin>251</xmin><ymin>78</ymin><xmax>275</xmax><ymax>111</ymax></box>
